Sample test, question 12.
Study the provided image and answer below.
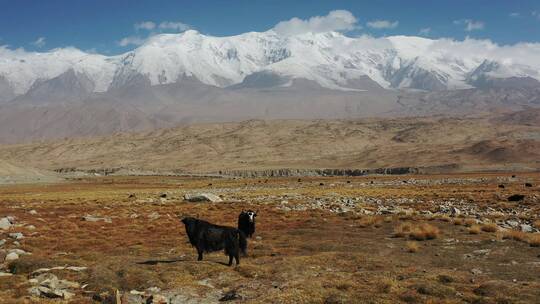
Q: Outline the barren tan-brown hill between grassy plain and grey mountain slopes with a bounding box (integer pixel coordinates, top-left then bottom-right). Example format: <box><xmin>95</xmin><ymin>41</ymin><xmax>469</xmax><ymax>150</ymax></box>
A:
<box><xmin>0</xmin><ymin>110</ymin><xmax>540</xmax><ymax>172</ymax></box>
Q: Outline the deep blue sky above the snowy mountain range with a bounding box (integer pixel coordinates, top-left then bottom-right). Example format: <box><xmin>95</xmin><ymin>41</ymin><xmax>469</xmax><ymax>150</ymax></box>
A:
<box><xmin>0</xmin><ymin>0</ymin><xmax>540</xmax><ymax>54</ymax></box>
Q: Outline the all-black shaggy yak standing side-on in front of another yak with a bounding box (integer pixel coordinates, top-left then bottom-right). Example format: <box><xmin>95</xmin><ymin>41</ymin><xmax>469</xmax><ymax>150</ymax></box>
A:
<box><xmin>182</xmin><ymin>217</ymin><xmax>247</xmax><ymax>266</ymax></box>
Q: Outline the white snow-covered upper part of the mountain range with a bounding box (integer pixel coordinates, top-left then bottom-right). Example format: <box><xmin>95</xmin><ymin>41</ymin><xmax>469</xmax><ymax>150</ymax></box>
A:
<box><xmin>0</xmin><ymin>30</ymin><xmax>540</xmax><ymax>100</ymax></box>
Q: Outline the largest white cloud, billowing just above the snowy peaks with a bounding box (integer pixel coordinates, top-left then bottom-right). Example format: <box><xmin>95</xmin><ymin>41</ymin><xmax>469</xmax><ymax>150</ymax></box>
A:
<box><xmin>273</xmin><ymin>10</ymin><xmax>361</xmax><ymax>35</ymax></box>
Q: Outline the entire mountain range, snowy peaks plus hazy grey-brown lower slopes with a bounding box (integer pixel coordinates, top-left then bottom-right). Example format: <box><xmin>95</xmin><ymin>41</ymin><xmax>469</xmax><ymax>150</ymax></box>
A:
<box><xmin>0</xmin><ymin>30</ymin><xmax>540</xmax><ymax>143</ymax></box>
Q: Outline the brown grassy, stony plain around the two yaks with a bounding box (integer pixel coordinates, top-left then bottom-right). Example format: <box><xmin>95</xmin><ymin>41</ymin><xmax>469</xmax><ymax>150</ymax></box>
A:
<box><xmin>0</xmin><ymin>173</ymin><xmax>540</xmax><ymax>303</ymax></box>
